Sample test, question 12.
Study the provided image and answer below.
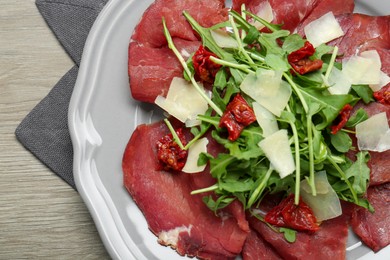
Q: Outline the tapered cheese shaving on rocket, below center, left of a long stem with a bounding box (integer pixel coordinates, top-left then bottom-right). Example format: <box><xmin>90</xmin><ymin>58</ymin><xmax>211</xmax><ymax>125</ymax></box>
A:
<box><xmin>259</xmin><ymin>129</ymin><xmax>295</xmax><ymax>178</ymax></box>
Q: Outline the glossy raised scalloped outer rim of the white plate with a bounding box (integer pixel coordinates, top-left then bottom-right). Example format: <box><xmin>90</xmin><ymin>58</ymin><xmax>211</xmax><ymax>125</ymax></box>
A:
<box><xmin>68</xmin><ymin>0</ymin><xmax>385</xmax><ymax>260</ymax></box>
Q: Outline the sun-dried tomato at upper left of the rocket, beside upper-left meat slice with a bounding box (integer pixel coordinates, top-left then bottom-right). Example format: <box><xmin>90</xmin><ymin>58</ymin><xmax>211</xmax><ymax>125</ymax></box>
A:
<box><xmin>192</xmin><ymin>45</ymin><xmax>222</xmax><ymax>83</ymax></box>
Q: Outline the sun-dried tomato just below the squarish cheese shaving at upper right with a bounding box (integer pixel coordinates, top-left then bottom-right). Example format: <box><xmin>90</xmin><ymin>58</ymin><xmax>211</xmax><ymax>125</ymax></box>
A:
<box><xmin>287</xmin><ymin>41</ymin><xmax>323</xmax><ymax>75</ymax></box>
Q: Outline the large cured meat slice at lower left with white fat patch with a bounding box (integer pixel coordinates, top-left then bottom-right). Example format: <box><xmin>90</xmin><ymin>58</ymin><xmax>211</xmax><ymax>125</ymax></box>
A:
<box><xmin>123</xmin><ymin>122</ymin><xmax>249</xmax><ymax>259</ymax></box>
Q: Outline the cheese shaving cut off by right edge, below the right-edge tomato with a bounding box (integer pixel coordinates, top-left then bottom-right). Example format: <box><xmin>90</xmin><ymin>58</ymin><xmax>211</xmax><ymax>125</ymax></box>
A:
<box><xmin>356</xmin><ymin>112</ymin><xmax>390</xmax><ymax>152</ymax></box>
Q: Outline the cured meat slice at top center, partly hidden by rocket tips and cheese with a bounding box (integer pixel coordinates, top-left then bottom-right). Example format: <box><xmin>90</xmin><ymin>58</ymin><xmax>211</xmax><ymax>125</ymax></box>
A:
<box><xmin>232</xmin><ymin>0</ymin><xmax>320</xmax><ymax>32</ymax></box>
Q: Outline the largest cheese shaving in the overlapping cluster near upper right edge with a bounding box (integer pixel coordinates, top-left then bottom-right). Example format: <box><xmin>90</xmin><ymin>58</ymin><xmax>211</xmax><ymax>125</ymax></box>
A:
<box><xmin>342</xmin><ymin>50</ymin><xmax>382</xmax><ymax>86</ymax></box>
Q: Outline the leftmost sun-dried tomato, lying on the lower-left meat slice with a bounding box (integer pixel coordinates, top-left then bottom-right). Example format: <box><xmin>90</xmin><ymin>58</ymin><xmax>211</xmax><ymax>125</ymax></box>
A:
<box><xmin>156</xmin><ymin>128</ymin><xmax>188</xmax><ymax>171</ymax></box>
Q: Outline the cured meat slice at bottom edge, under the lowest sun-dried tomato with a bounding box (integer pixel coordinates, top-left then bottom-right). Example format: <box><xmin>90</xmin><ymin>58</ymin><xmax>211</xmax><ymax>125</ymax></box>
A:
<box><xmin>247</xmin><ymin>197</ymin><xmax>350</xmax><ymax>260</ymax></box>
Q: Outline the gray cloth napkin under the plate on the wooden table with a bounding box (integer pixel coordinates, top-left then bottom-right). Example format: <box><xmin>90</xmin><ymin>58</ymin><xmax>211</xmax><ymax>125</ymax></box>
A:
<box><xmin>15</xmin><ymin>0</ymin><xmax>108</xmax><ymax>189</ymax></box>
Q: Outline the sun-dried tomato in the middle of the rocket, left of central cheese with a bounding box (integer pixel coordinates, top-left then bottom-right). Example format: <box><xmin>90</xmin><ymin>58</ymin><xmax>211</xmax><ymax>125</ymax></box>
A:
<box><xmin>219</xmin><ymin>94</ymin><xmax>256</xmax><ymax>141</ymax></box>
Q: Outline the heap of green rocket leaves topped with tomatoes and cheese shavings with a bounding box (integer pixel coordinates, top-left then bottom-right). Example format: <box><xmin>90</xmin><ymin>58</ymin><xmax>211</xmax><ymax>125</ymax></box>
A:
<box><xmin>156</xmin><ymin>6</ymin><xmax>374</xmax><ymax>238</ymax></box>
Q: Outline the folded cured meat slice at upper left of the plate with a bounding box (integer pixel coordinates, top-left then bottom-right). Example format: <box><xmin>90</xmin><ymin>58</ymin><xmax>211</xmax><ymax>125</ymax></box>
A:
<box><xmin>128</xmin><ymin>0</ymin><xmax>227</xmax><ymax>103</ymax></box>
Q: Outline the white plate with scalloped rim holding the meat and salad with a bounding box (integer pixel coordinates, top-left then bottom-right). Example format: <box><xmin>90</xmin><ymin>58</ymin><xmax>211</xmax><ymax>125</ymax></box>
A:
<box><xmin>69</xmin><ymin>0</ymin><xmax>390</xmax><ymax>260</ymax></box>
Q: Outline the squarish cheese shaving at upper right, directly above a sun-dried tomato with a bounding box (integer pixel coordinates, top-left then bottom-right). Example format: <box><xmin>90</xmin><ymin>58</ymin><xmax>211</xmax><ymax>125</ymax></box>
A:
<box><xmin>303</xmin><ymin>12</ymin><xmax>344</xmax><ymax>47</ymax></box>
